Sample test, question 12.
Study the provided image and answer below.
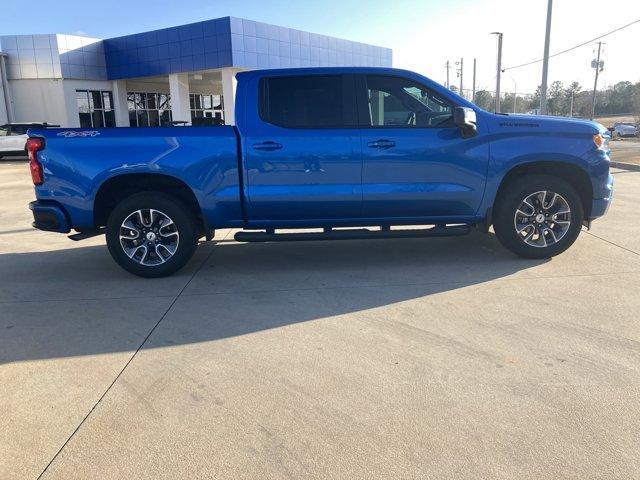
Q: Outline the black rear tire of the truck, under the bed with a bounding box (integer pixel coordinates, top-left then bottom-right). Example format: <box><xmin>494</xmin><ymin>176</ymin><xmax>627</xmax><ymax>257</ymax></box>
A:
<box><xmin>106</xmin><ymin>192</ymin><xmax>198</xmax><ymax>278</ymax></box>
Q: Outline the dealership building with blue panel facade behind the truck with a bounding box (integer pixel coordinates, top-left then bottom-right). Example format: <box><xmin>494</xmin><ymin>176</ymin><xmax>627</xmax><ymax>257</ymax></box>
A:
<box><xmin>0</xmin><ymin>17</ymin><xmax>392</xmax><ymax>128</ymax></box>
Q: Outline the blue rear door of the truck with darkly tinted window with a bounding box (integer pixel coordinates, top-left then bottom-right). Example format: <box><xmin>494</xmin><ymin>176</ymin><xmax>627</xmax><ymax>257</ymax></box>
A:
<box><xmin>242</xmin><ymin>73</ymin><xmax>362</xmax><ymax>224</ymax></box>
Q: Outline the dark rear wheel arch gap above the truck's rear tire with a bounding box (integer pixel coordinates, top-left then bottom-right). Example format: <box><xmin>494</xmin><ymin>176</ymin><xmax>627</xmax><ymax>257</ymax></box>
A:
<box><xmin>93</xmin><ymin>173</ymin><xmax>207</xmax><ymax>233</ymax></box>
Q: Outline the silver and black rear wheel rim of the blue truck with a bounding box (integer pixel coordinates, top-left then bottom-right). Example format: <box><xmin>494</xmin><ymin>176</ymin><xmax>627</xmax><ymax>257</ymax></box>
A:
<box><xmin>120</xmin><ymin>208</ymin><xmax>180</xmax><ymax>267</ymax></box>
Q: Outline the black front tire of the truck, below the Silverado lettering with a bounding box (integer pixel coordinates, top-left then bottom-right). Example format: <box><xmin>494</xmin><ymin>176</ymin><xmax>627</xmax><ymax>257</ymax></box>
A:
<box><xmin>493</xmin><ymin>175</ymin><xmax>584</xmax><ymax>259</ymax></box>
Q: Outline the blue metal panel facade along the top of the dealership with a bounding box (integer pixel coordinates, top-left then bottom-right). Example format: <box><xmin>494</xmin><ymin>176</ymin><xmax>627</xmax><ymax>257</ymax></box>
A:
<box><xmin>104</xmin><ymin>17</ymin><xmax>392</xmax><ymax>79</ymax></box>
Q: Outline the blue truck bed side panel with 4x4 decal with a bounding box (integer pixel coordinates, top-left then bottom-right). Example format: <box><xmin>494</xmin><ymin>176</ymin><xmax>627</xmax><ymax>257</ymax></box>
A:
<box><xmin>29</xmin><ymin>126</ymin><xmax>242</xmax><ymax>228</ymax></box>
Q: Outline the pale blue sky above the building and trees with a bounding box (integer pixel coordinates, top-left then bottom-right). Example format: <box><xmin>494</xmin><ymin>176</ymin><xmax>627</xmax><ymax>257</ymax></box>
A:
<box><xmin>0</xmin><ymin>0</ymin><xmax>640</xmax><ymax>93</ymax></box>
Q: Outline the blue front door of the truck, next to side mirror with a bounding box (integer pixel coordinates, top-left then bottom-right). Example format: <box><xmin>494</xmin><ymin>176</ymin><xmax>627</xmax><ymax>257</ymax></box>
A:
<box><xmin>357</xmin><ymin>75</ymin><xmax>489</xmax><ymax>218</ymax></box>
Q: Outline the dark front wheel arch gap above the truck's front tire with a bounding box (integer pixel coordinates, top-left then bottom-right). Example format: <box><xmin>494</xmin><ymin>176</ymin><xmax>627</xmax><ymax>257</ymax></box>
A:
<box><xmin>491</xmin><ymin>160</ymin><xmax>593</xmax><ymax>222</ymax></box>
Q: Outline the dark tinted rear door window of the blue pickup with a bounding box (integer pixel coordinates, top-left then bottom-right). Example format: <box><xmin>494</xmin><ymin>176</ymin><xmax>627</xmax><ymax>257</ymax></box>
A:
<box><xmin>260</xmin><ymin>75</ymin><xmax>357</xmax><ymax>128</ymax></box>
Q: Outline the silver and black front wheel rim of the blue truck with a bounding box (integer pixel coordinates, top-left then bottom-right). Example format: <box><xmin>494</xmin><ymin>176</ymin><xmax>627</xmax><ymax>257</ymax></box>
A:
<box><xmin>513</xmin><ymin>190</ymin><xmax>571</xmax><ymax>248</ymax></box>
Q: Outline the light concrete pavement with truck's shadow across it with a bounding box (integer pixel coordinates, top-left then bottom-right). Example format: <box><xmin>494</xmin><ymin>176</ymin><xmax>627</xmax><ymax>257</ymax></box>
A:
<box><xmin>0</xmin><ymin>162</ymin><xmax>640</xmax><ymax>479</ymax></box>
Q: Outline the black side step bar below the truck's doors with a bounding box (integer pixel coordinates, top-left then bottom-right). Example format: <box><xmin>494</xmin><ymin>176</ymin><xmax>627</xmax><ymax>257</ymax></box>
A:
<box><xmin>233</xmin><ymin>225</ymin><xmax>471</xmax><ymax>242</ymax></box>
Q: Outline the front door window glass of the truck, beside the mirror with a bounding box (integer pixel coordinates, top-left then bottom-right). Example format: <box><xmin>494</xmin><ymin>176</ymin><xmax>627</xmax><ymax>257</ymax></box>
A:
<box><xmin>366</xmin><ymin>75</ymin><xmax>453</xmax><ymax>128</ymax></box>
